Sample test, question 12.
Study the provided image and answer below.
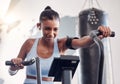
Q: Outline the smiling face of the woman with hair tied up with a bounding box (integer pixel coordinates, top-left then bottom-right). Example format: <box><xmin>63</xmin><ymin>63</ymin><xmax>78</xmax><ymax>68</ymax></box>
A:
<box><xmin>41</xmin><ymin>19</ymin><xmax>59</xmax><ymax>40</ymax></box>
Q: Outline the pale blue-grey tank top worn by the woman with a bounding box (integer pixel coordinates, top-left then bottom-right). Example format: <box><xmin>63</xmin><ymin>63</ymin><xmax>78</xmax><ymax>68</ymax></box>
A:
<box><xmin>26</xmin><ymin>38</ymin><xmax>60</xmax><ymax>77</ymax></box>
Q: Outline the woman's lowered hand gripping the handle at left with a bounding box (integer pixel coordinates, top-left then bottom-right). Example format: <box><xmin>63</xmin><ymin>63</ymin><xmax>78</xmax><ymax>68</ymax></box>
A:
<box><xmin>10</xmin><ymin>58</ymin><xmax>24</xmax><ymax>71</ymax></box>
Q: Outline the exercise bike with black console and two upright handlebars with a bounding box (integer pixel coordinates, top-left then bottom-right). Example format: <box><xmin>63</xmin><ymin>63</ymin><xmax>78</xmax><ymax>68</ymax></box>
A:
<box><xmin>5</xmin><ymin>30</ymin><xmax>115</xmax><ymax>84</ymax></box>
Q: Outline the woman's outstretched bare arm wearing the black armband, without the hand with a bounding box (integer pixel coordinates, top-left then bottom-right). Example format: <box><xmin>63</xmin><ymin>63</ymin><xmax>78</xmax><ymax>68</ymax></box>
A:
<box><xmin>59</xmin><ymin>36</ymin><xmax>93</xmax><ymax>52</ymax></box>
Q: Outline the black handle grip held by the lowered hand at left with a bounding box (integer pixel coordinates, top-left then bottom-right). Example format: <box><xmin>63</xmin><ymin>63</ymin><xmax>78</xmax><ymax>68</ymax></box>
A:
<box><xmin>5</xmin><ymin>59</ymin><xmax>35</xmax><ymax>66</ymax></box>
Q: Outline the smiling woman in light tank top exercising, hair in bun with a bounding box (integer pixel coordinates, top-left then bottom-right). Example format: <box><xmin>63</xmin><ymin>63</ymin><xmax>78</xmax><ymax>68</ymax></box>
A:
<box><xmin>9</xmin><ymin>6</ymin><xmax>111</xmax><ymax>84</ymax></box>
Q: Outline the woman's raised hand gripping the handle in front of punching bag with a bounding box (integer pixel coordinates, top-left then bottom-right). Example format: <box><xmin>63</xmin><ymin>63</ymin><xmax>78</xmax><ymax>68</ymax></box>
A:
<box><xmin>98</xmin><ymin>26</ymin><xmax>111</xmax><ymax>37</ymax></box>
